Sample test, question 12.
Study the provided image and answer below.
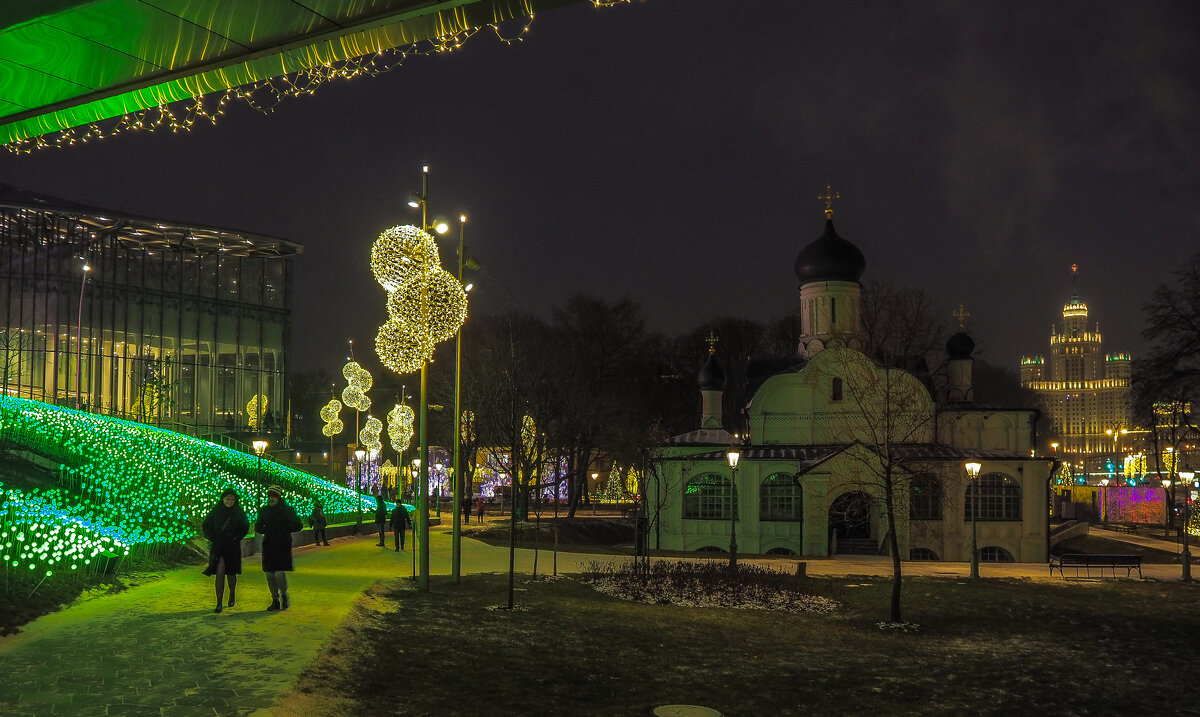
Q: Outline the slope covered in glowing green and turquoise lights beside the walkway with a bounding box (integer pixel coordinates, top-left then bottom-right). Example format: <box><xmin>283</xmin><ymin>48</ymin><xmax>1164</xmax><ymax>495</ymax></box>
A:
<box><xmin>0</xmin><ymin>396</ymin><xmax>373</xmax><ymax>587</ymax></box>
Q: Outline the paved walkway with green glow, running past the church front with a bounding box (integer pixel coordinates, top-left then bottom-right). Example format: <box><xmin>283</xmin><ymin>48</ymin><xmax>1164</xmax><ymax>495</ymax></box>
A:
<box><xmin>0</xmin><ymin>529</ymin><xmax>1180</xmax><ymax>716</ymax></box>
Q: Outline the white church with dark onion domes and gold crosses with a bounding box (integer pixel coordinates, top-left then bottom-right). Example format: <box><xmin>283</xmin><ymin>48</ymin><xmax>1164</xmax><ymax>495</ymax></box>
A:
<box><xmin>647</xmin><ymin>198</ymin><xmax>1057</xmax><ymax>562</ymax></box>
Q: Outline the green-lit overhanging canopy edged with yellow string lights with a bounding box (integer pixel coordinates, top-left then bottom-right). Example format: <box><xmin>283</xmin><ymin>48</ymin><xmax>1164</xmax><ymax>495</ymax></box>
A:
<box><xmin>0</xmin><ymin>0</ymin><xmax>575</xmax><ymax>144</ymax></box>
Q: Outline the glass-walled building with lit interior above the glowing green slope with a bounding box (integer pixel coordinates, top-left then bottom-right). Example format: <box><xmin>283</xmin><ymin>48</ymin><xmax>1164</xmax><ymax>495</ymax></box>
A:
<box><xmin>0</xmin><ymin>185</ymin><xmax>301</xmax><ymax>435</ymax></box>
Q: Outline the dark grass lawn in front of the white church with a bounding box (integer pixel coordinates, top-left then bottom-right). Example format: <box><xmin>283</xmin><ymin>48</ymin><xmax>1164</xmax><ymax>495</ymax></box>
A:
<box><xmin>277</xmin><ymin>574</ymin><xmax>1200</xmax><ymax>717</ymax></box>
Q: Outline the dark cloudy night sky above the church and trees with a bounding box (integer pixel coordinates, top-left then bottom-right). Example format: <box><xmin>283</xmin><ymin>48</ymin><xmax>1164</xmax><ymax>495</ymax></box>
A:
<box><xmin>0</xmin><ymin>0</ymin><xmax>1200</xmax><ymax>370</ymax></box>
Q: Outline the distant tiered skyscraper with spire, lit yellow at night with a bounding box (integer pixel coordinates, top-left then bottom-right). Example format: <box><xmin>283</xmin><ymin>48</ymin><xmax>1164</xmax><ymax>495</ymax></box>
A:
<box><xmin>1021</xmin><ymin>265</ymin><xmax>1133</xmax><ymax>454</ymax></box>
